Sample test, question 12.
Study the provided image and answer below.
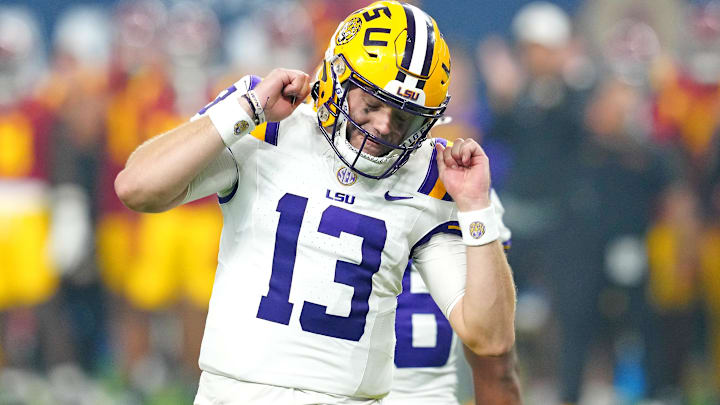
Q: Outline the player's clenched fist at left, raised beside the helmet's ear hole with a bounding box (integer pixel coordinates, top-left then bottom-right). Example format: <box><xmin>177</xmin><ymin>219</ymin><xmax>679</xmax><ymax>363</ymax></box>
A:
<box><xmin>255</xmin><ymin>69</ymin><xmax>310</xmax><ymax>122</ymax></box>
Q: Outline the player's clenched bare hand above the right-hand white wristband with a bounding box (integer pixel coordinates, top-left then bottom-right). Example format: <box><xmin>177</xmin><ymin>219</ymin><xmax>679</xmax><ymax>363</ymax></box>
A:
<box><xmin>435</xmin><ymin>138</ymin><xmax>490</xmax><ymax>211</ymax></box>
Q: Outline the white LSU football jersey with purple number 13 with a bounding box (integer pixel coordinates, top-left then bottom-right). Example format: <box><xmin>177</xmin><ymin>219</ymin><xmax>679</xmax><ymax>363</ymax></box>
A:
<box><xmin>200</xmin><ymin>76</ymin><xmax>465</xmax><ymax>398</ymax></box>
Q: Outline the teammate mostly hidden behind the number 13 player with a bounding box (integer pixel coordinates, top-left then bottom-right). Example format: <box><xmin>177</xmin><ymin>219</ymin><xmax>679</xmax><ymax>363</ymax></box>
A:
<box><xmin>383</xmin><ymin>191</ymin><xmax>520</xmax><ymax>405</ymax></box>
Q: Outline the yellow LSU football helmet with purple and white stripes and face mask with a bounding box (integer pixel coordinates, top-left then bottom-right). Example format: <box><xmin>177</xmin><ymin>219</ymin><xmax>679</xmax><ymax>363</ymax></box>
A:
<box><xmin>313</xmin><ymin>1</ymin><xmax>450</xmax><ymax>179</ymax></box>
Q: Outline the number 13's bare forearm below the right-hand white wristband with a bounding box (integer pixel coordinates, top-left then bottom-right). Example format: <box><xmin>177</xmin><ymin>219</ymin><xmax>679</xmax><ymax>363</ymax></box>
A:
<box><xmin>451</xmin><ymin>241</ymin><xmax>515</xmax><ymax>355</ymax></box>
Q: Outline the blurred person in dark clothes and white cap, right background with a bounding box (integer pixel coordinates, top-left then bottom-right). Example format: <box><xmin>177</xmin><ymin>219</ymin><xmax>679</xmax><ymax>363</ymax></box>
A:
<box><xmin>479</xmin><ymin>2</ymin><xmax>602</xmax><ymax>402</ymax></box>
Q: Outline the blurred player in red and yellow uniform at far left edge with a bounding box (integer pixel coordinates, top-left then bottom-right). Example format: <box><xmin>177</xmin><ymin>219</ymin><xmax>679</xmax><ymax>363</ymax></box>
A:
<box><xmin>0</xmin><ymin>6</ymin><xmax>82</xmax><ymax>402</ymax></box>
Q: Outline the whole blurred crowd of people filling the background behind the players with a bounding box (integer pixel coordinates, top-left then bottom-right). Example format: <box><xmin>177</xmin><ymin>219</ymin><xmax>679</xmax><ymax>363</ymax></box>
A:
<box><xmin>0</xmin><ymin>0</ymin><xmax>720</xmax><ymax>405</ymax></box>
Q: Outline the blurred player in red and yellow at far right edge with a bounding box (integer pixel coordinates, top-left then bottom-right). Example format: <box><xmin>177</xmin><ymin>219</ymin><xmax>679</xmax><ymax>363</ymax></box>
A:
<box><xmin>649</xmin><ymin>0</ymin><xmax>720</xmax><ymax>397</ymax></box>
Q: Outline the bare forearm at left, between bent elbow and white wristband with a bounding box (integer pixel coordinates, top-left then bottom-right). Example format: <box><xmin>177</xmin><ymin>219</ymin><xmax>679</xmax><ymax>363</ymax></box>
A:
<box><xmin>115</xmin><ymin>117</ymin><xmax>225</xmax><ymax>212</ymax></box>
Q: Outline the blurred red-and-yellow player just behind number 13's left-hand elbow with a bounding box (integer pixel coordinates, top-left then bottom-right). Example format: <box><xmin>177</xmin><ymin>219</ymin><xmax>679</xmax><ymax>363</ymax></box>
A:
<box><xmin>97</xmin><ymin>1</ymin><xmax>176</xmax><ymax>398</ymax></box>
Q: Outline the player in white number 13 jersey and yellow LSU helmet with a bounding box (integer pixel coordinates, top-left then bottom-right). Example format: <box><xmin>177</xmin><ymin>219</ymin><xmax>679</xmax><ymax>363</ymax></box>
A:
<box><xmin>115</xmin><ymin>1</ymin><xmax>515</xmax><ymax>404</ymax></box>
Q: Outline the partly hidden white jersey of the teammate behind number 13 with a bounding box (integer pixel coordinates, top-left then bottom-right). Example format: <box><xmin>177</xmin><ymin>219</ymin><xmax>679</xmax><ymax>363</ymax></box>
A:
<box><xmin>383</xmin><ymin>190</ymin><xmax>511</xmax><ymax>405</ymax></box>
